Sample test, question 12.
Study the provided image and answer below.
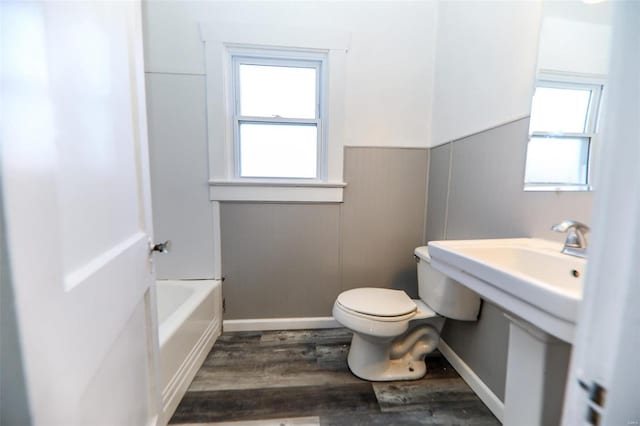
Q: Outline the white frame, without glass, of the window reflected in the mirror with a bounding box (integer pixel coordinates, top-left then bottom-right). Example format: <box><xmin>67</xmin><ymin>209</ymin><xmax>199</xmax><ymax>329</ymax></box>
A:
<box><xmin>524</xmin><ymin>70</ymin><xmax>606</xmax><ymax>192</ymax></box>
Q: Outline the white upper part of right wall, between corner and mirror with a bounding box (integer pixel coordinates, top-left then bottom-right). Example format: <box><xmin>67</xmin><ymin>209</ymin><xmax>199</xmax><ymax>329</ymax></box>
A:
<box><xmin>430</xmin><ymin>1</ymin><xmax>542</xmax><ymax>146</ymax></box>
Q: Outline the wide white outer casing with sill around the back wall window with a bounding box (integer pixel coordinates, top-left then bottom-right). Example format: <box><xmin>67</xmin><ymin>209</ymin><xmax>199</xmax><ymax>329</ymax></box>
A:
<box><xmin>200</xmin><ymin>22</ymin><xmax>350</xmax><ymax>203</ymax></box>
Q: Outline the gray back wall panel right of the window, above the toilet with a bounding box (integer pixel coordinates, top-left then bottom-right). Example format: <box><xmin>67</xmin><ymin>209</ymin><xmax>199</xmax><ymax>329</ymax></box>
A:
<box><xmin>342</xmin><ymin>148</ymin><xmax>428</xmax><ymax>297</ymax></box>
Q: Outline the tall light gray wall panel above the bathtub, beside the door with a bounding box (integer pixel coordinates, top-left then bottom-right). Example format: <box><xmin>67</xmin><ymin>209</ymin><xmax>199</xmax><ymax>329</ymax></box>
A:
<box><xmin>146</xmin><ymin>73</ymin><xmax>214</xmax><ymax>279</ymax></box>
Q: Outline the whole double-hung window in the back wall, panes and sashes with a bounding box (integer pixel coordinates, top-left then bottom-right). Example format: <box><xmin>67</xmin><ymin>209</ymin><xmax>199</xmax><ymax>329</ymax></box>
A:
<box><xmin>231</xmin><ymin>50</ymin><xmax>326</xmax><ymax>181</ymax></box>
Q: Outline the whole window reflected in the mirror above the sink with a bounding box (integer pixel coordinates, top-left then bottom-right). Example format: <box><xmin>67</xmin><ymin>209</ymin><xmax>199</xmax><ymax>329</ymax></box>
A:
<box><xmin>525</xmin><ymin>80</ymin><xmax>602</xmax><ymax>189</ymax></box>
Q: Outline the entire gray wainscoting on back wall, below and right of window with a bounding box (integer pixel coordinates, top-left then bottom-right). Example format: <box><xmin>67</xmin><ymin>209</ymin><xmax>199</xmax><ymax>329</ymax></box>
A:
<box><xmin>221</xmin><ymin>147</ymin><xmax>428</xmax><ymax>319</ymax></box>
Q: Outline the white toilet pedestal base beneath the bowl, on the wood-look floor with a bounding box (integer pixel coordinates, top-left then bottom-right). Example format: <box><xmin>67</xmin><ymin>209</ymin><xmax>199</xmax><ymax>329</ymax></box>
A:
<box><xmin>347</xmin><ymin>325</ymin><xmax>439</xmax><ymax>381</ymax></box>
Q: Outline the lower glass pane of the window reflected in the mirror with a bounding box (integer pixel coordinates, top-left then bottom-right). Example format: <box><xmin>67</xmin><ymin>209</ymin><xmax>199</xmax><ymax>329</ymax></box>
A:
<box><xmin>524</xmin><ymin>136</ymin><xmax>589</xmax><ymax>185</ymax></box>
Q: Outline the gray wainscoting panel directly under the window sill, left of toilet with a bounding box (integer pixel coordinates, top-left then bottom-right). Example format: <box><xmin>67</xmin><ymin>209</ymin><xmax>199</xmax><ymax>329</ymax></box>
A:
<box><xmin>221</xmin><ymin>203</ymin><xmax>340</xmax><ymax>319</ymax></box>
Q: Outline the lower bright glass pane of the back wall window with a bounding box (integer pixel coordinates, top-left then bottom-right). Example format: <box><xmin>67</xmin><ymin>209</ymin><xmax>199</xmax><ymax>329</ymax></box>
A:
<box><xmin>240</xmin><ymin>123</ymin><xmax>318</xmax><ymax>178</ymax></box>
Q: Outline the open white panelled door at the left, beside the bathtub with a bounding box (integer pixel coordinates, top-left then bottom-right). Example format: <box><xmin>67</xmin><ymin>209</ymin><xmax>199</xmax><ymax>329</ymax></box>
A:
<box><xmin>1</xmin><ymin>1</ymin><xmax>159</xmax><ymax>426</ymax></box>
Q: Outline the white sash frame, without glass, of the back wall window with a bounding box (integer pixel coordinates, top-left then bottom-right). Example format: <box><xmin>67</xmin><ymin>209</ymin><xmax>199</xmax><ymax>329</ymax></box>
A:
<box><xmin>227</xmin><ymin>47</ymin><xmax>328</xmax><ymax>183</ymax></box>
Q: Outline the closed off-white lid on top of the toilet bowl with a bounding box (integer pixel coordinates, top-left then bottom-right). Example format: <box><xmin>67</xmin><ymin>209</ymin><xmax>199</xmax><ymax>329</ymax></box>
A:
<box><xmin>338</xmin><ymin>288</ymin><xmax>417</xmax><ymax>317</ymax></box>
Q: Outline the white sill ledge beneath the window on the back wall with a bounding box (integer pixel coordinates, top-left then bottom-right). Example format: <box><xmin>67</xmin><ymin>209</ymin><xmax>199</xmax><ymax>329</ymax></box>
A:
<box><xmin>209</xmin><ymin>180</ymin><xmax>347</xmax><ymax>203</ymax></box>
